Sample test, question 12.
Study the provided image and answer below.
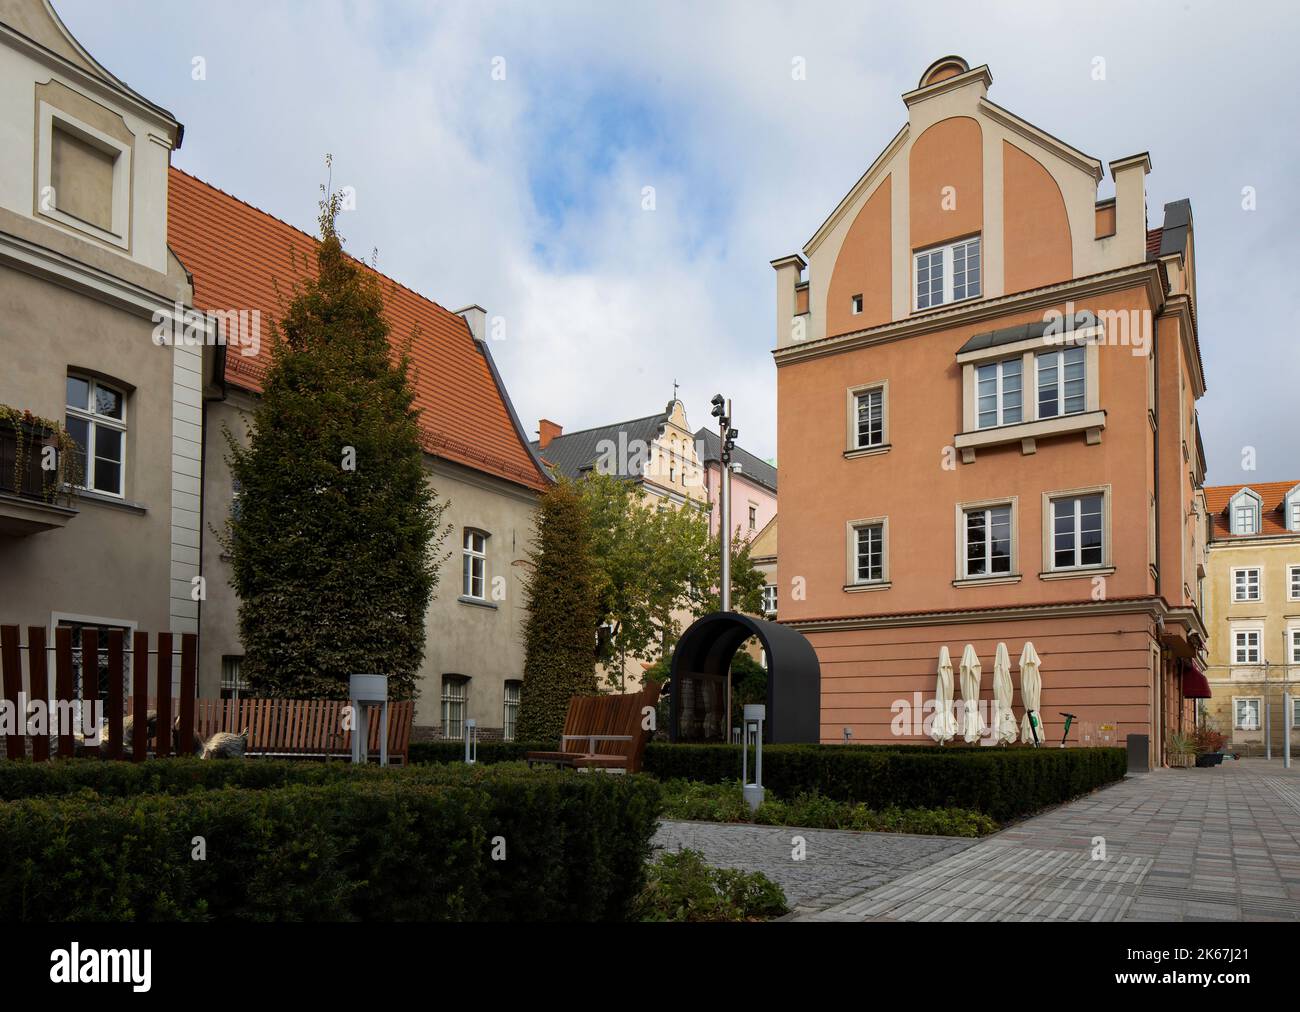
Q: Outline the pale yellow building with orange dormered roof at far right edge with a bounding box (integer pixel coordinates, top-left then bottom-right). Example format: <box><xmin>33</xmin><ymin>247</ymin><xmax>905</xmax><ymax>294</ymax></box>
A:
<box><xmin>1204</xmin><ymin>481</ymin><xmax>1300</xmax><ymax>756</ymax></box>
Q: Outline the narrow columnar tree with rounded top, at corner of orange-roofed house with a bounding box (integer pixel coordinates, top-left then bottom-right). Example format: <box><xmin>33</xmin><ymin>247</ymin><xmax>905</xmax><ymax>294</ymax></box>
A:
<box><xmin>517</xmin><ymin>480</ymin><xmax>598</xmax><ymax>741</ymax></box>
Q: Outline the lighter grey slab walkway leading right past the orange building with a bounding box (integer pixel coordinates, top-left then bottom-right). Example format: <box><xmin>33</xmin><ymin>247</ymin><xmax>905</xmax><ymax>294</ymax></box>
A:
<box><xmin>798</xmin><ymin>760</ymin><xmax>1300</xmax><ymax>921</ymax></box>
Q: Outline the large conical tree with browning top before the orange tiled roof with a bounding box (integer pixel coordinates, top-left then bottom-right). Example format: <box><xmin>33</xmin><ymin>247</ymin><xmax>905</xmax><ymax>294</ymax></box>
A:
<box><xmin>220</xmin><ymin>189</ymin><xmax>447</xmax><ymax>699</ymax></box>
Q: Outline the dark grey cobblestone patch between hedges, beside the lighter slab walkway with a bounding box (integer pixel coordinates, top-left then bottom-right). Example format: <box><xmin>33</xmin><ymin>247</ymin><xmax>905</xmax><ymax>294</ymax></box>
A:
<box><xmin>654</xmin><ymin>822</ymin><xmax>975</xmax><ymax>914</ymax></box>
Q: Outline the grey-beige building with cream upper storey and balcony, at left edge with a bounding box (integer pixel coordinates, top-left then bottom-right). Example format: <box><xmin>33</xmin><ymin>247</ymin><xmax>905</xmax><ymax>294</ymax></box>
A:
<box><xmin>0</xmin><ymin>0</ymin><xmax>200</xmax><ymax>681</ymax></box>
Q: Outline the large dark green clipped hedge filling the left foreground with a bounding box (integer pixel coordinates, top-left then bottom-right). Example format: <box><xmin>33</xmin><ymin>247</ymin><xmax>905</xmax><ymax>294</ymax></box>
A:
<box><xmin>0</xmin><ymin>760</ymin><xmax>660</xmax><ymax>921</ymax></box>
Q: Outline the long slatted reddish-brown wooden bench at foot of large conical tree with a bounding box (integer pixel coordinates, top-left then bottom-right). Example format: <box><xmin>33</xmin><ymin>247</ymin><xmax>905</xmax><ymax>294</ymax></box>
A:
<box><xmin>127</xmin><ymin>699</ymin><xmax>415</xmax><ymax>766</ymax></box>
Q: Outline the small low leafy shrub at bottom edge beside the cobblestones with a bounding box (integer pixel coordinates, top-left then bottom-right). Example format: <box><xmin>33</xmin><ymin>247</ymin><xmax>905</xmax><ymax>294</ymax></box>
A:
<box><xmin>634</xmin><ymin>851</ymin><xmax>789</xmax><ymax>921</ymax></box>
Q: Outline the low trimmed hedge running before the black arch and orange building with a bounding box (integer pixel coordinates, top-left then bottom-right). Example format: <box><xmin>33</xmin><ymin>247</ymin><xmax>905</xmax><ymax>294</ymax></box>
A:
<box><xmin>411</xmin><ymin>741</ymin><xmax>1127</xmax><ymax>822</ymax></box>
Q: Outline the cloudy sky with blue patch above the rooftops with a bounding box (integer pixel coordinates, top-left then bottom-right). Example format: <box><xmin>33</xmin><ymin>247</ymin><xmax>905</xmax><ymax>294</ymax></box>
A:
<box><xmin>55</xmin><ymin>0</ymin><xmax>1300</xmax><ymax>484</ymax></box>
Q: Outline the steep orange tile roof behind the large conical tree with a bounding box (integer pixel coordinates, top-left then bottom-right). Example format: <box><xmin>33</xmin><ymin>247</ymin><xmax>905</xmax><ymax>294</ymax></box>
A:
<box><xmin>168</xmin><ymin>168</ymin><xmax>549</xmax><ymax>489</ymax></box>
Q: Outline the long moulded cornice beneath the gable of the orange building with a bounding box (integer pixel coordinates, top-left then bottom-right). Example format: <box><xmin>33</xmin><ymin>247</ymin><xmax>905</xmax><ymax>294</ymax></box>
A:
<box><xmin>772</xmin><ymin>261</ymin><xmax>1165</xmax><ymax>368</ymax></box>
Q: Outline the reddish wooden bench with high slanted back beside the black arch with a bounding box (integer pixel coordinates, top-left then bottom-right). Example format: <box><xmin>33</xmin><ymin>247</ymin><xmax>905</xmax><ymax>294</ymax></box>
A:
<box><xmin>525</xmin><ymin>684</ymin><xmax>660</xmax><ymax>773</ymax></box>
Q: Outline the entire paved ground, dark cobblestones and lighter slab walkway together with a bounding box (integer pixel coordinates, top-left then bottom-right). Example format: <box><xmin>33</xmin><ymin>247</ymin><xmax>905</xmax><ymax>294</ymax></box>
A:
<box><xmin>659</xmin><ymin>760</ymin><xmax>1300</xmax><ymax>921</ymax></box>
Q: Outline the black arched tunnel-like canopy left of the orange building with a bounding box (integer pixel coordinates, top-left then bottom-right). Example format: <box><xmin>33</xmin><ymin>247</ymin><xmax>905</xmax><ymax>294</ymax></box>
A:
<box><xmin>668</xmin><ymin>611</ymin><xmax>822</xmax><ymax>743</ymax></box>
